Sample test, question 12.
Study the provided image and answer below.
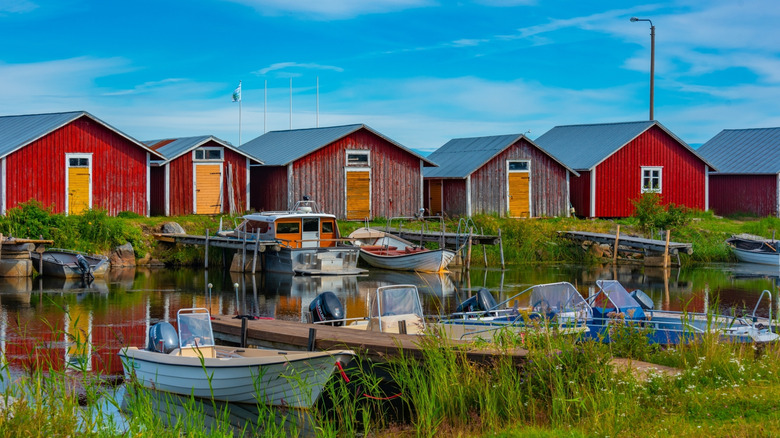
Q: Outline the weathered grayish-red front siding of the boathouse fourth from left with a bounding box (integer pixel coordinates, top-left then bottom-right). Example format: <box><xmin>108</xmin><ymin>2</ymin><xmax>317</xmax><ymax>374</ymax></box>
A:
<box><xmin>466</xmin><ymin>139</ymin><xmax>569</xmax><ymax>217</ymax></box>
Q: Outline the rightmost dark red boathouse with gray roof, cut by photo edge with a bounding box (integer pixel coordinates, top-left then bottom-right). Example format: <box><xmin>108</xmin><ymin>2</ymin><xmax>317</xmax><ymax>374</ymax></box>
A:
<box><xmin>697</xmin><ymin>128</ymin><xmax>780</xmax><ymax>216</ymax></box>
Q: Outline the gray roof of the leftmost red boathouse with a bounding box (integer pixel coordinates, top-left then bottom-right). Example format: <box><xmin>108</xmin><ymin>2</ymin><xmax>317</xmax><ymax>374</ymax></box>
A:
<box><xmin>0</xmin><ymin>111</ymin><xmax>162</xmax><ymax>158</ymax></box>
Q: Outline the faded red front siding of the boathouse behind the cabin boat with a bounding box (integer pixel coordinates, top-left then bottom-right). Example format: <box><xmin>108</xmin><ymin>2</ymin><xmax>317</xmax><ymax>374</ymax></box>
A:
<box><xmin>278</xmin><ymin>129</ymin><xmax>422</xmax><ymax>219</ymax></box>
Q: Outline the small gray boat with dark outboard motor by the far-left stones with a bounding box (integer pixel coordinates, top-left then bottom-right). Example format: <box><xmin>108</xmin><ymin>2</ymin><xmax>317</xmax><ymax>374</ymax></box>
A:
<box><xmin>30</xmin><ymin>248</ymin><xmax>111</xmax><ymax>278</ymax></box>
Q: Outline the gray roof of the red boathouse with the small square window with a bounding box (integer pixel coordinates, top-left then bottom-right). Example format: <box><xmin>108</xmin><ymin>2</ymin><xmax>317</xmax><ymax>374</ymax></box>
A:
<box><xmin>536</xmin><ymin>120</ymin><xmax>714</xmax><ymax>170</ymax></box>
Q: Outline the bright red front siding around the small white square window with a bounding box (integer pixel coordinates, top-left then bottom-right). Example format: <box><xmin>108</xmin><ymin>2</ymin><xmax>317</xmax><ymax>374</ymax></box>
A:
<box><xmin>595</xmin><ymin>126</ymin><xmax>705</xmax><ymax>217</ymax></box>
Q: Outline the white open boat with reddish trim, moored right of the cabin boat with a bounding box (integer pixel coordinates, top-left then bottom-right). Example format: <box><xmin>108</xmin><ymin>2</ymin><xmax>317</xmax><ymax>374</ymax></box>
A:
<box><xmin>349</xmin><ymin>227</ymin><xmax>455</xmax><ymax>272</ymax></box>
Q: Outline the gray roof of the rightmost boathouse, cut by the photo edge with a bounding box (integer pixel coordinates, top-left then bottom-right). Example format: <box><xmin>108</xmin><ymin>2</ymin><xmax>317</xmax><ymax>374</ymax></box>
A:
<box><xmin>696</xmin><ymin>128</ymin><xmax>780</xmax><ymax>174</ymax></box>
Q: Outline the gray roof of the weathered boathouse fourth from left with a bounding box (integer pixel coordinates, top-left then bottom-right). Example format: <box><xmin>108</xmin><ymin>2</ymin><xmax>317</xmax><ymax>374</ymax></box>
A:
<box><xmin>424</xmin><ymin>134</ymin><xmax>576</xmax><ymax>178</ymax></box>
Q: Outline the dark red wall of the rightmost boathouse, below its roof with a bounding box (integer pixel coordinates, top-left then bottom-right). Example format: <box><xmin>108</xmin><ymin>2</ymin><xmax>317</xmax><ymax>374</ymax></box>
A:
<box><xmin>710</xmin><ymin>173</ymin><xmax>778</xmax><ymax>216</ymax></box>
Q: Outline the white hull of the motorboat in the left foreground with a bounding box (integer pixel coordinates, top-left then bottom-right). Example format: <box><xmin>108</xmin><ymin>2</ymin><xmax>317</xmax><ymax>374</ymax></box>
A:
<box><xmin>119</xmin><ymin>347</ymin><xmax>353</xmax><ymax>408</ymax></box>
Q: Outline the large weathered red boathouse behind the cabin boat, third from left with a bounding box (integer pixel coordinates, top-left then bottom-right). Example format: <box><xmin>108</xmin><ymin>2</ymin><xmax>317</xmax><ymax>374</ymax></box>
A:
<box><xmin>240</xmin><ymin>124</ymin><xmax>435</xmax><ymax>220</ymax></box>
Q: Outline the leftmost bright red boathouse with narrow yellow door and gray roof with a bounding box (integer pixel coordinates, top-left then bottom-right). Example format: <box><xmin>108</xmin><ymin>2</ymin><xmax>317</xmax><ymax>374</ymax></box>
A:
<box><xmin>0</xmin><ymin>111</ymin><xmax>162</xmax><ymax>215</ymax></box>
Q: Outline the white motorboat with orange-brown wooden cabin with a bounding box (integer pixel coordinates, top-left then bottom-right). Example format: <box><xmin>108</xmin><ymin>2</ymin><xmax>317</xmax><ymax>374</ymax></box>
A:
<box><xmin>218</xmin><ymin>198</ymin><xmax>365</xmax><ymax>275</ymax></box>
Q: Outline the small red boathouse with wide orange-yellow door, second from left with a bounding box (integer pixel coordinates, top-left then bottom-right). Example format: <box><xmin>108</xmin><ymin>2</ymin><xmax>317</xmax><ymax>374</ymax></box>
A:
<box><xmin>144</xmin><ymin>135</ymin><xmax>262</xmax><ymax>216</ymax></box>
